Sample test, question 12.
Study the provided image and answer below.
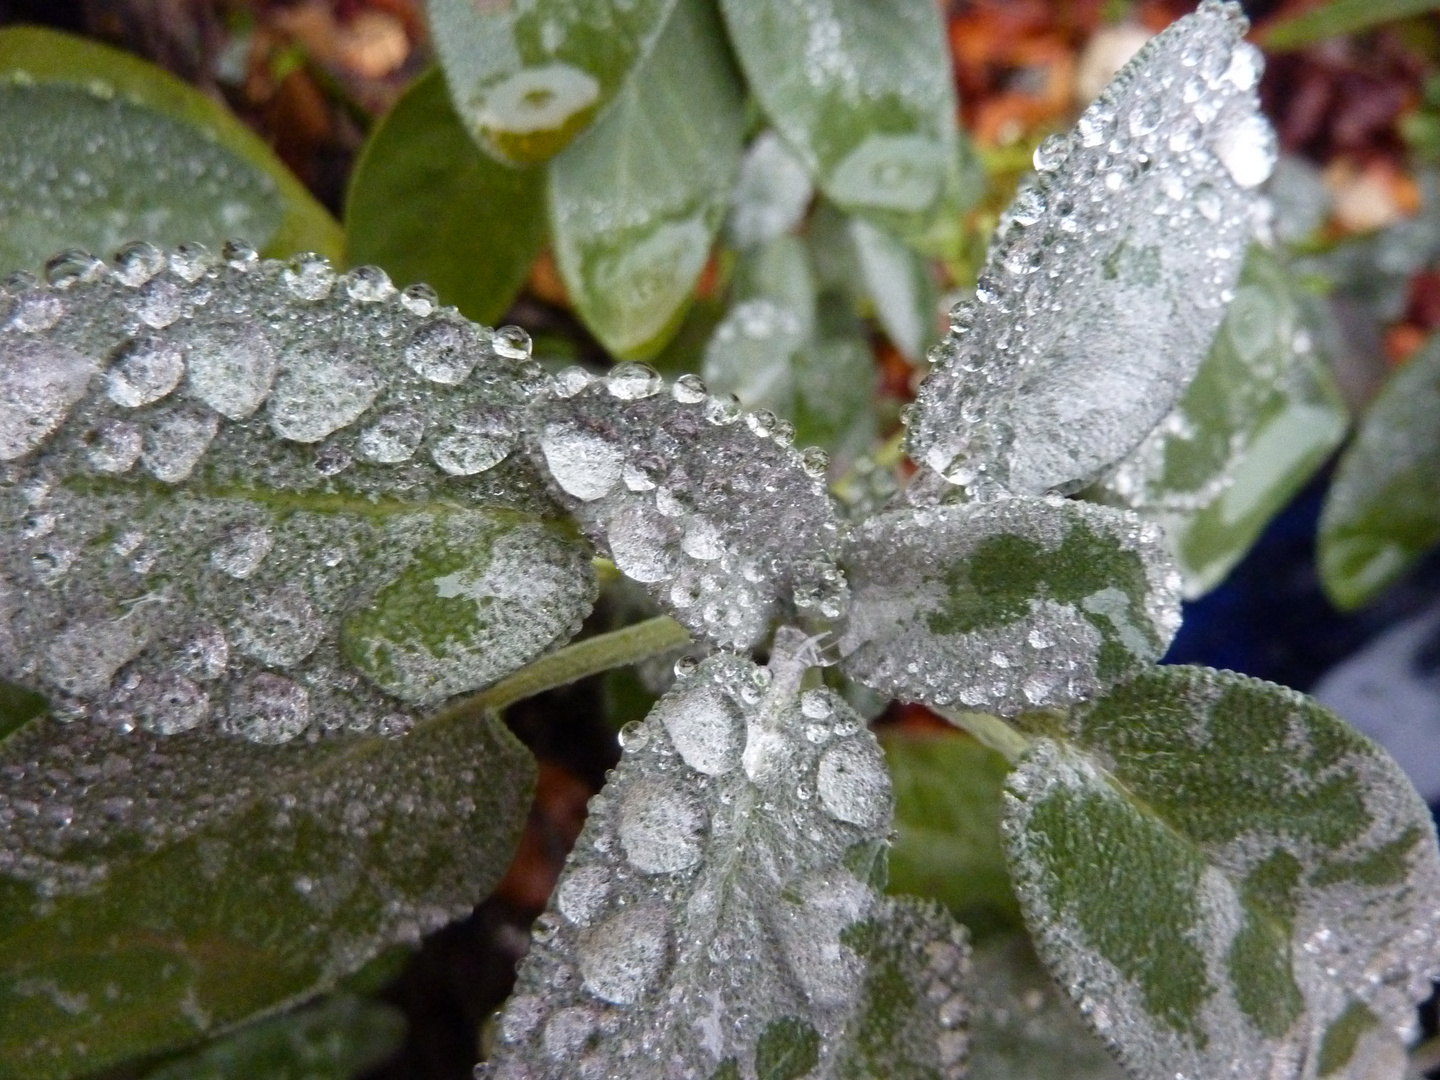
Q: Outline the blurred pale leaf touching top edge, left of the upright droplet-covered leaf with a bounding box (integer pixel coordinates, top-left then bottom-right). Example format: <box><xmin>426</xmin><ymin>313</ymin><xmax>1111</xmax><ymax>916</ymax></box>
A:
<box><xmin>721</xmin><ymin>0</ymin><xmax>976</xmax><ymax>258</ymax></box>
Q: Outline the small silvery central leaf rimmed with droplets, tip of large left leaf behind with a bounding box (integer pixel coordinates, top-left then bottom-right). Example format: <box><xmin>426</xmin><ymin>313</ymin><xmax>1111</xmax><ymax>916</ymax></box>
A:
<box><xmin>528</xmin><ymin>364</ymin><xmax>848</xmax><ymax>647</ymax></box>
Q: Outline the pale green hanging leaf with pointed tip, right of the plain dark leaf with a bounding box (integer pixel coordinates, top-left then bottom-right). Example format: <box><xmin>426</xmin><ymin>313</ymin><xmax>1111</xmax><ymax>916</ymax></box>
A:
<box><xmin>550</xmin><ymin>0</ymin><xmax>744</xmax><ymax>359</ymax></box>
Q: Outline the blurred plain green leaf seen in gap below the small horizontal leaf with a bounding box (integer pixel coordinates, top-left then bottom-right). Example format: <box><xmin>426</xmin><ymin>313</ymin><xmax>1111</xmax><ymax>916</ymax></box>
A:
<box><xmin>880</xmin><ymin>730</ymin><xmax>1021</xmax><ymax>936</ymax></box>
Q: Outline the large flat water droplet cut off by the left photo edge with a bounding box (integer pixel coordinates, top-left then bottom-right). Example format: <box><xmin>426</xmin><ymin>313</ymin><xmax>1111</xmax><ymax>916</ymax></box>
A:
<box><xmin>0</xmin><ymin>338</ymin><xmax>96</xmax><ymax>461</ymax></box>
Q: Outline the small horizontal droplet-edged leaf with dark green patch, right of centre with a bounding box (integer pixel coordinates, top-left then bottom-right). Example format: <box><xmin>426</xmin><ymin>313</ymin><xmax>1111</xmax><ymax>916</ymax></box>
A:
<box><xmin>840</xmin><ymin>497</ymin><xmax>1179</xmax><ymax>716</ymax></box>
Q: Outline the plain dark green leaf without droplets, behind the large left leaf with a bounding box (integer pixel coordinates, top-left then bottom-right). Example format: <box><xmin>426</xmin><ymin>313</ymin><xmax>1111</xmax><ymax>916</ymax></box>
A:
<box><xmin>346</xmin><ymin>71</ymin><xmax>546</xmax><ymax>323</ymax></box>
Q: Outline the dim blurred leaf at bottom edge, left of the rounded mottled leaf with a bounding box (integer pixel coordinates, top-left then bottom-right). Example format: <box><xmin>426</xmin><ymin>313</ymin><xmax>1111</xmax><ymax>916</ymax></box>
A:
<box><xmin>965</xmin><ymin>933</ymin><xmax>1126</xmax><ymax>1080</ymax></box>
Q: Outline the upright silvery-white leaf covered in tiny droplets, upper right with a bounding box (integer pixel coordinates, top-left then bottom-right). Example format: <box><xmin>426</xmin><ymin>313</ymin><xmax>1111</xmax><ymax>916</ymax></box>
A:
<box><xmin>910</xmin><ymin>0</ymin><xmax>1276</xmax><ymax>495</ymax></box>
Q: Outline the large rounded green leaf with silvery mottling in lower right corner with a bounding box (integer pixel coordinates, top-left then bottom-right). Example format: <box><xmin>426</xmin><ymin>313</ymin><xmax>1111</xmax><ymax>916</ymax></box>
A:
<box><xmin>1004</xmin><ymin>667</ymin><xmax>1440</xmax><ymax>1080</ymax></box>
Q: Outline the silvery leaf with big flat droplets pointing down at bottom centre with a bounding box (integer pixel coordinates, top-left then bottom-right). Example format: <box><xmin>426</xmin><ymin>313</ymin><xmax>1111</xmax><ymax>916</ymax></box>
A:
<box><xmin>490</xmin><ymin>631</ymin><xmax>968</xmax><ymax>1080</ymax></box>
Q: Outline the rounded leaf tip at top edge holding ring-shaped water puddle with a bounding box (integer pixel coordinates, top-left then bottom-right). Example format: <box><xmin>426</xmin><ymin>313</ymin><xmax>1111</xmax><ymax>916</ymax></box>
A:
<box><xmin>426</xmin><ymin>0</ymin><xmax>675</xmax><ymax>166</ymax></box>
